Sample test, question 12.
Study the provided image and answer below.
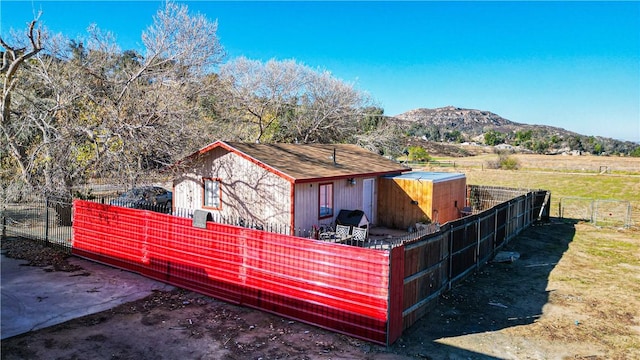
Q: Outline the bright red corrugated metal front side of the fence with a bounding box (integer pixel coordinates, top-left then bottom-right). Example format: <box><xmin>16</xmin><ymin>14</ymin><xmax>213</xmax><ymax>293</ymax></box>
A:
<box><xmin>72</xmin><ymin>200</ymin><xmax>404</xmax><ymax>344</ymax></box>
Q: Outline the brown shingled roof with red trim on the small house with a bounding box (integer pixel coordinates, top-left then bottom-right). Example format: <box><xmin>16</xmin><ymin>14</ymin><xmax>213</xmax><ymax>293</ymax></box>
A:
<box><xmin>189</xmin><ymin>141</ymin><xmax>411</xmax><ymax>182</ymax></box>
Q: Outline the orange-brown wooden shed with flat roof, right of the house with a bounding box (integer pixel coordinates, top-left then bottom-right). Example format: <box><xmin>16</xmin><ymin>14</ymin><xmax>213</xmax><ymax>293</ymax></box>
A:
<box><xmin>378</xmin><ymin>171</ymin><xmax>467</xmax><ymax>229</ymax></box>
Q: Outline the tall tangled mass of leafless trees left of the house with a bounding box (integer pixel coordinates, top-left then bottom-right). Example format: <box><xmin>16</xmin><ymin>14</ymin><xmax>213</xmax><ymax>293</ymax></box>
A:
<box><xmin>0</xmin><ymin>2</ymin><xmax>224</xmax><ymax>201</ymax></box>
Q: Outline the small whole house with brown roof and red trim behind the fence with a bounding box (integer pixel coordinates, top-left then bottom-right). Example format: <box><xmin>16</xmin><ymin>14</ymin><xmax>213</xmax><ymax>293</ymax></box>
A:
<box><xmin>173</xmin><ymin>141</ymin><xmax>411</xmax><ymax>230</ymax></box>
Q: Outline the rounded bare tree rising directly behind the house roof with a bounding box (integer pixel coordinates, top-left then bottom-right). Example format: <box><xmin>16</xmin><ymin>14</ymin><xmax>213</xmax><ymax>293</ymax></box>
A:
<box><xmin>220</xmin><ymin>58</ymin><xmax>371</xmax><ymax>143</ymax></box>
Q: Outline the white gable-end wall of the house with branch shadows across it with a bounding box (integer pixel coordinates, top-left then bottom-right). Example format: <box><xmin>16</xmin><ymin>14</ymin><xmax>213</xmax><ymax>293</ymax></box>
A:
<box><xmin>173</xmin><ymin>148</ymin><xmax>291</xmax><ymax>226</ymax></box>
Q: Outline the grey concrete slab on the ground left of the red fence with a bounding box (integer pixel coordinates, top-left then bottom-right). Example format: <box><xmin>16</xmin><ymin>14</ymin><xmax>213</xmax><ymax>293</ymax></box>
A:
<box><xmin>0</xmin><ymin>255</ymin><xmax>173</xmax><ymax>339</ymax></box>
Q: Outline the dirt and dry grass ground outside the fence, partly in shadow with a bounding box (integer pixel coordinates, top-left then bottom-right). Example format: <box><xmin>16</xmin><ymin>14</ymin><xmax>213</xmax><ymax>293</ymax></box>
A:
<box><xmin>1</xmin><ymin>219</ymin><xmax>640</xmax><ymax>360</ymax></box>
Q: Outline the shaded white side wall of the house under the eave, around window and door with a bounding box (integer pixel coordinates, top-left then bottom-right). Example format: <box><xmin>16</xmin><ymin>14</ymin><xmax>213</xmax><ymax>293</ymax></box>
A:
<box><xmin>295</xmin><ymin>178</ymin><xmax>377</xmax><ymax>230</ymax></box>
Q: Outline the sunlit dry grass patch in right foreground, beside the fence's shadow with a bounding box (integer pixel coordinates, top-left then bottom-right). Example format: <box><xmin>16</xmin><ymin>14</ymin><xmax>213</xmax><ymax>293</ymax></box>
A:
<box><xmin>509</xmin><ymin>224</ymin><xmax>640</xmax><ymax>359</ymax></box>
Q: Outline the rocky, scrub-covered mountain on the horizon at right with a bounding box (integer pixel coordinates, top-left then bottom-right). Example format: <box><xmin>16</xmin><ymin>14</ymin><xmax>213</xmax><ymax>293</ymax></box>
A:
<box><xmin>392</xmin><ymin>106</ymin><xmax>638</xmax><ymax>154</ymax></box>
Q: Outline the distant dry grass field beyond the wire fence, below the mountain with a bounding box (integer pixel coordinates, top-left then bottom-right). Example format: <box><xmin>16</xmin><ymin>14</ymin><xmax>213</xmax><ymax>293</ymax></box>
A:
<box><xmin>425</xmin><ymin>154</ymin><xmax>640</xmax><ymax>229</ymax></box>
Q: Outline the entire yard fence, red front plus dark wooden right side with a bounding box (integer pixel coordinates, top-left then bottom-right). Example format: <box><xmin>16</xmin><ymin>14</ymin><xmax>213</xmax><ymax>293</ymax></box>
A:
<box><xmin>72</xmin><ymin>189</ymin><xmax>549</xmax><ymax>345</ymax></box>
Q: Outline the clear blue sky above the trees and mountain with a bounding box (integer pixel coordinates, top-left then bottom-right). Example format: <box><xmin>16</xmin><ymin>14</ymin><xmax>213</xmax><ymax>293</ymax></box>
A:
<box><xmin>0</xmin><ymin>0</ymin><xmax>640</xmax><ymax>142</ymax></box>
